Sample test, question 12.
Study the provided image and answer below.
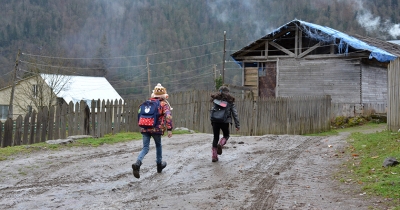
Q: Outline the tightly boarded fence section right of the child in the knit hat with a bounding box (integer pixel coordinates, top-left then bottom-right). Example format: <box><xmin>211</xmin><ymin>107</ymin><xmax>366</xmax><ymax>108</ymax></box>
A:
<box><xmin>169</xmin><ymin>91</ymin><xmax>331</xmax><ymax>135</ymax></box>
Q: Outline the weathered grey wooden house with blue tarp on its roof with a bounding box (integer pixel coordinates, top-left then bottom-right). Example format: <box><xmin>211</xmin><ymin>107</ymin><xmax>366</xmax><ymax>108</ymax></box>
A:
<box><xmin>231</xmin><ymin>20</ymin><xmax>400</xmax><ymax>115</ymax></box>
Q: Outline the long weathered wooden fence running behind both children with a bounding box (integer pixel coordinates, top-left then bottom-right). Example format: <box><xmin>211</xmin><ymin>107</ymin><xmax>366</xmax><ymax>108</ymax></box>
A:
<box><xmin>0</xmin><ymin>91</ymin><xmax>331</xmax><ymax>147</ymax></box>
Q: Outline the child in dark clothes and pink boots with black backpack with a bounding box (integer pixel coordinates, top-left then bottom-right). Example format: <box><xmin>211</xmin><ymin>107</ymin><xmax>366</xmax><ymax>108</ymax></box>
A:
<box><xmin>210</xmin><ymin>86</ymin><xmax>240</xmax><ymax>162</ymax></box>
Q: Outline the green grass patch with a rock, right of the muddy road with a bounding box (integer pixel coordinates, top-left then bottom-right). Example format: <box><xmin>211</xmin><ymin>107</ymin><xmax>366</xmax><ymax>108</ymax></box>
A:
<box><xmin>337</xmin><ymin>124</ymin><xmax>400</xmax><ymax>210</ymax></box>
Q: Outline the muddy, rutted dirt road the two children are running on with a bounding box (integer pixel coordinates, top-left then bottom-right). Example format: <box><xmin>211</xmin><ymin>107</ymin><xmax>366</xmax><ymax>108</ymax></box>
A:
<box><xmin>0</xmin><ymin>131</ymin><xmax>383</xmax><ymax>210</ymax></box>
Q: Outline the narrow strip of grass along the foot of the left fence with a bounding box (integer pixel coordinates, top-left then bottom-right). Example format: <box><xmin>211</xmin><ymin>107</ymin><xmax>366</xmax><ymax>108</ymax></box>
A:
<box><xmin>0</xmin><ymin>130</ymin><xmax>189</xmax><ymax>161</ymax></box>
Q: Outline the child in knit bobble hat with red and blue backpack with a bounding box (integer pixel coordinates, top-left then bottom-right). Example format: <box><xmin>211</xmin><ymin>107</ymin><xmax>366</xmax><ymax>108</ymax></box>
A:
<box><xmin>132</xmin><ymin>83</ymin><xmax>173</xmax><ymax>179</ymax></box>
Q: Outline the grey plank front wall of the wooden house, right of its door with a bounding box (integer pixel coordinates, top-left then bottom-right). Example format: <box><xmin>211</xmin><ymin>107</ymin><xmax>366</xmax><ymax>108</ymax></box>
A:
<box><xmin>277</xmin><ymin>59</ymin><xmax>361</xmax><ymax>103</ymax></box>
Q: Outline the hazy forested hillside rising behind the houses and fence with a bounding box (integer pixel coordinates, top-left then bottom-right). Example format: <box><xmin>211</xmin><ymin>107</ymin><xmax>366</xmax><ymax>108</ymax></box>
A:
<box><xmin>0</xmin><ymin>0</ymin><xmax>400</xmax><ymax>98</ymax></box>
